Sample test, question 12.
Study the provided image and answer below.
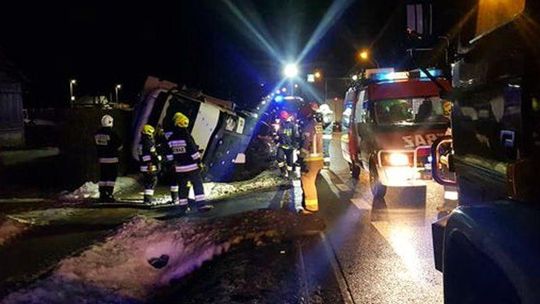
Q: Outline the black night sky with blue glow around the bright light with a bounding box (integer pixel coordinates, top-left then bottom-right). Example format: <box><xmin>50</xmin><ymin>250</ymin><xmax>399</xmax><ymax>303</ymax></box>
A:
<box><xmin>0</xmin><ymin>0</ymin><xmax>399</xmax><ymax>107</ymax></box>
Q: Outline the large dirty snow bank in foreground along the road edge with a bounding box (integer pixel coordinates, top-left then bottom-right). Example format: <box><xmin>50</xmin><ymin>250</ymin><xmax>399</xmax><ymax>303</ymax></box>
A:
<box><xmin>3</xmin><ymin>210</ymin><xmax>323</xmax><ymax>303</ymax></box>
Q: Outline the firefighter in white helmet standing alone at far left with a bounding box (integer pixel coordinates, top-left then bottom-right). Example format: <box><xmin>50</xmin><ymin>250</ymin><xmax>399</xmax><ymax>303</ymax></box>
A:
<box><xmin>94</xmin><ymin>115</ymin><xmax>122</xmax><ymax>202</ymax></box>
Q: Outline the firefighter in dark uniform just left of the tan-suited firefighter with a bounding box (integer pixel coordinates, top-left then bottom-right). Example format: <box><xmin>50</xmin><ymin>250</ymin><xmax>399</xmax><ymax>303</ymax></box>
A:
<box><xmin>276</xmin><ymin>111</ymin><xmax>298</xmax><ymax>178</ymax></box>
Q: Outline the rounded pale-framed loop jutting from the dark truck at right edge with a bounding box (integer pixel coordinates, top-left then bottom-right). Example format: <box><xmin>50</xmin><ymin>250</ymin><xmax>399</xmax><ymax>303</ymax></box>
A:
<box><xmin>431</xmin><ymin>136</ymin><xmax>457</xmax><ymax>186</ymax></box>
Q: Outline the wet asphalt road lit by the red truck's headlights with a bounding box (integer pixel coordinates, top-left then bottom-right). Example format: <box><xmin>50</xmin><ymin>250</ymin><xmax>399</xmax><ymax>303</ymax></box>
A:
<box><xmin>318</xmin><ymin>135</ymin><xmax>443</xmax><ymax>303</ymax></box>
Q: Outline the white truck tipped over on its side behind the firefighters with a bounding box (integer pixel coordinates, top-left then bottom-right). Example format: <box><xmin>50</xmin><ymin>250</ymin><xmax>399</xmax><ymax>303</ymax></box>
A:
<box><xmin>131</xmin><ymin>77</ymin><xmax>264</xmax><ymax>182</ymax></box>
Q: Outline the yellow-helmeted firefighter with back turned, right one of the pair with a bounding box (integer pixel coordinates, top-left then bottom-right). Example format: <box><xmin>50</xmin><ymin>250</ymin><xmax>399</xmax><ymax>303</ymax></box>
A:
<box><xmin>168</xmin><ymin>113</ymin><xmax>213</xmax><ymax>211</ymax></box>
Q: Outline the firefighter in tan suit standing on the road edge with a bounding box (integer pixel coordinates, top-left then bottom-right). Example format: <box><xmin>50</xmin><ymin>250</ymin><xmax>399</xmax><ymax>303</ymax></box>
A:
<box><xmin>300</xmin><ymin>103</ymin><xmax>323</xmax><ymax>214</ymax></box>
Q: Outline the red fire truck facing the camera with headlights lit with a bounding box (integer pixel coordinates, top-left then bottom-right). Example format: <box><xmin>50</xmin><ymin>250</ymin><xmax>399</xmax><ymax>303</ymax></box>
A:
<box><xmin>341</xmin><ymin>68</ymin><xmax>450</xmax><ymax>198</ymax></box>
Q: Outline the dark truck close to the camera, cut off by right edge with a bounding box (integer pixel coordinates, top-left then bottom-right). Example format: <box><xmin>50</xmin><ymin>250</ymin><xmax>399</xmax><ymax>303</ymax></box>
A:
<box><xmin>432</xmin><ymin>0</ymin><xmax>540</xmax><ymax>304</ymax></box>
